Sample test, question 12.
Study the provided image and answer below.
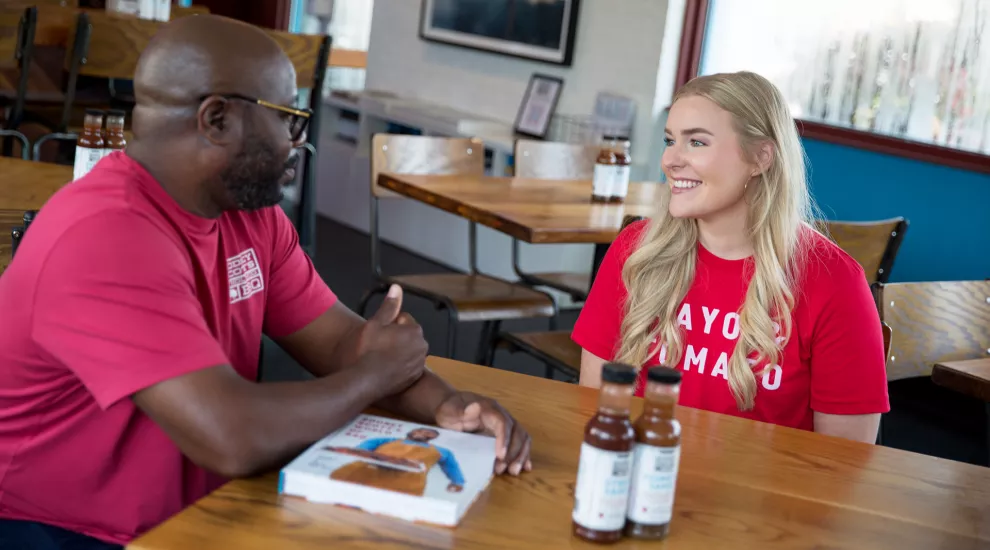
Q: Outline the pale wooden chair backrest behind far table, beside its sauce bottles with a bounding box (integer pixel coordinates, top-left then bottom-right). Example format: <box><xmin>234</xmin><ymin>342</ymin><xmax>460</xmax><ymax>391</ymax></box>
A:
<box><xmin>513</xmin><ymin>139</ymin><xmax>598</xmax><ymax>180</ymax></box>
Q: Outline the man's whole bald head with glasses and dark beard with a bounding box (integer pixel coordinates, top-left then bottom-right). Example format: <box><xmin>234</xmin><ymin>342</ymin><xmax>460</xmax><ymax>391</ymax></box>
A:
<box><xmin>127</xmin><ymin>15</ymin><xmax>305</xmax><ymax>217</ymax></box>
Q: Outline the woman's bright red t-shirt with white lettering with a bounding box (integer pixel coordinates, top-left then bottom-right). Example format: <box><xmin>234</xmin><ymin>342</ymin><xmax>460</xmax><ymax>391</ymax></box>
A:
<box><xmin>572</xmin><ymin>221</ymin><xmax>890</xmax><ymax>430</ymax></box>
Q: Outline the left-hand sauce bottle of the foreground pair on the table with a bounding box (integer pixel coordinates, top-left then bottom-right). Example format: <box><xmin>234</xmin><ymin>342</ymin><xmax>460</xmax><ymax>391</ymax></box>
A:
<box><xmin>571</xmin><ymin>363</ymin><xmax>637</xmax><ymax>542</ymax></box>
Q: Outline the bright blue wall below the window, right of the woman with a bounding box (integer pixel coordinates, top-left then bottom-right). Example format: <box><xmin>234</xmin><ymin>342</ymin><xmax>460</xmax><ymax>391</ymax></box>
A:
<box><xmin>804</xmin><ymin>139</ymin><xmax>990</xmax><ymax>282</ymax></box>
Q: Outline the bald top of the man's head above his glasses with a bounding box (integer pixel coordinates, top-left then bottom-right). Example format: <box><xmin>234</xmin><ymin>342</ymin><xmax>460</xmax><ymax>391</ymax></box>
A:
<box><xmin>134</xmin><ymin>15</ymin><xmax>296</xmax><ymax>112</ymax></box>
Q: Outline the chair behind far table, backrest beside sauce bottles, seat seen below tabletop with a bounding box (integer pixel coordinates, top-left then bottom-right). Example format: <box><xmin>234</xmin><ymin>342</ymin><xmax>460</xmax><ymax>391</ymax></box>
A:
<box><xmin>512</xmin><ymin>139</ymin><xmax>599</xmax><ymax>302</ymax></box>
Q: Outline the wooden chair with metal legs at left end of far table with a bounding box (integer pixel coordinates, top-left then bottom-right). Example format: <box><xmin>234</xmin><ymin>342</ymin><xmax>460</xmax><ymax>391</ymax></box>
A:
<box><xmin>358</xmin><ymin>134</ymin><xmax>557</xmax><ymax>362</ymax></box>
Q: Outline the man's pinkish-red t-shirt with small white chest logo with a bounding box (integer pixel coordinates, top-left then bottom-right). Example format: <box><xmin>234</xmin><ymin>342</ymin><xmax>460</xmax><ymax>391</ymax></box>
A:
<box><xmin>0</xmin><ymin>153</ymin><xmax>336</xmax><ymax>544</ymax></box>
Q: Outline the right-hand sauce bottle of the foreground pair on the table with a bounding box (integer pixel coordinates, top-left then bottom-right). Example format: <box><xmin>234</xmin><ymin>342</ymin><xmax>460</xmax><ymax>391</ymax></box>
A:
<box><xmin>625</xmin><ymin>367</ymin><xmax>681</xmax><ymax>539</ymax></box>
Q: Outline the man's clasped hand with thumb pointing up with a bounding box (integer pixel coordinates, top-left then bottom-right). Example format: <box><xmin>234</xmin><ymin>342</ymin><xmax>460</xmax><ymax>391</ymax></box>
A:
<box><xmin>340</xmin><ymin>285</ymin><xmax>429</xmax><ymax>397</ymax></box>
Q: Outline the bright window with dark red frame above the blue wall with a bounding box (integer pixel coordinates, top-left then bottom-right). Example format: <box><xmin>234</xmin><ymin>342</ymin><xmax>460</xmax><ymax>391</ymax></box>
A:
<box><xmin>682</xmin><ymin>0</ymin><xmax>990</xmax><ymax>171</ymax></box>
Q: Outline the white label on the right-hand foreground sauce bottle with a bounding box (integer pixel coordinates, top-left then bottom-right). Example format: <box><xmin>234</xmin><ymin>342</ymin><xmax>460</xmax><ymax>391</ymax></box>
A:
<box><xmin>627</xmin><ymin>444</ymin><xmax>681</xmax><ymax>525</ymax></box>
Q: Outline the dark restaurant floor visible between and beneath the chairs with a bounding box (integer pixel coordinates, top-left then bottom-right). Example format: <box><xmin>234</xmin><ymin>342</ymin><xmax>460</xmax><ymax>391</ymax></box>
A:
<box><xmin>262</xmin><ymin>218</ymin><xmax>987</xmax><ymax>465</ymax></box>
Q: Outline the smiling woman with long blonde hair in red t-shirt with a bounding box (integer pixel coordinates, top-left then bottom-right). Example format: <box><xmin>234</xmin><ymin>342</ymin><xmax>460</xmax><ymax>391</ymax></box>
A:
<box><xmin>572</xmin><ymin>72</ymin><xmax>889</xmax><ymax>443</ymax></box>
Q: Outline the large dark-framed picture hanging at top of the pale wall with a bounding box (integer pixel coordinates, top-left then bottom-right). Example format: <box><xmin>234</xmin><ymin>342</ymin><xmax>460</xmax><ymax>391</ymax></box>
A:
<box><xmin>419</xmin><ymin>0</ymin><xmax>578</xmax><ymax>65</ymax></box>
